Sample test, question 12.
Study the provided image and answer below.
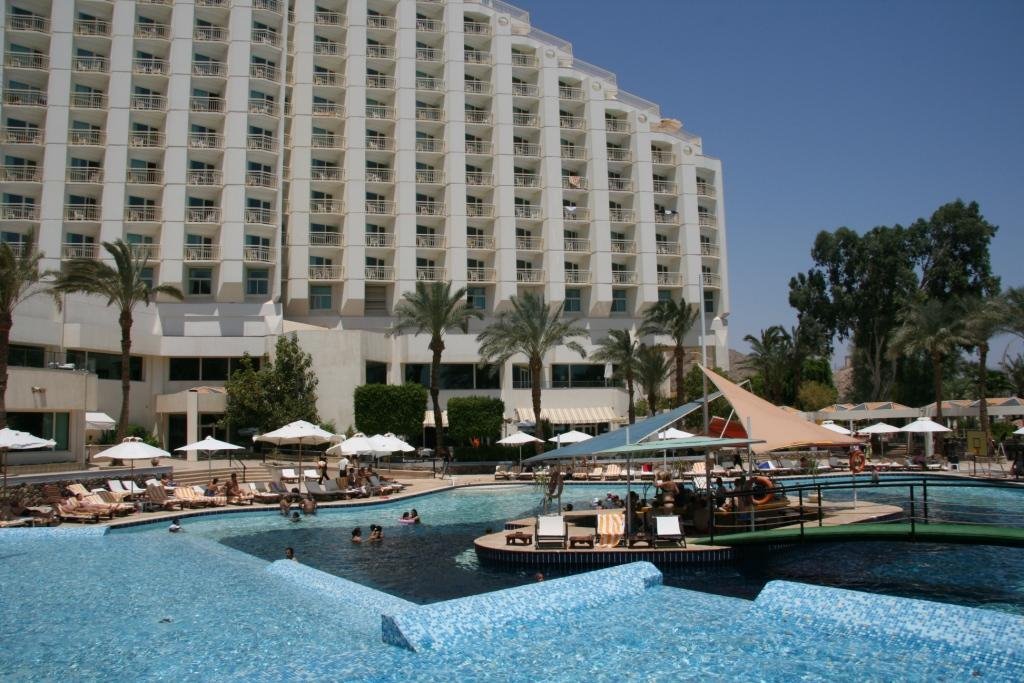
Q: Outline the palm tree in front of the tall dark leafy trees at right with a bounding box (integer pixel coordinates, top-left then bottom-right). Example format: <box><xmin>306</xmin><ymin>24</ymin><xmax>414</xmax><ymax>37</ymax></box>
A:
<box><xmin>889</xmin><ymin>299</ymin><xmax>971</xmax><ymax>420</ymax></box>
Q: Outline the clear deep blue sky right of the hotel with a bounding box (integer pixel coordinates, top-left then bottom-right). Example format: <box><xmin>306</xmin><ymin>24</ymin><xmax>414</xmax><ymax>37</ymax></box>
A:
<box><xmin>513</xmin><ymin>0</ymin><xmax>1024</xmax><ymax>360</ymax></box>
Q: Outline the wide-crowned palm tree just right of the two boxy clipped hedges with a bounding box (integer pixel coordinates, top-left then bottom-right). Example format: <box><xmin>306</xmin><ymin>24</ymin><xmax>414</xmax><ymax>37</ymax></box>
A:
<box><xmin>476</xmin><ymin>292</ymin><xmax>587</xmax><ymax>453</ymax></box>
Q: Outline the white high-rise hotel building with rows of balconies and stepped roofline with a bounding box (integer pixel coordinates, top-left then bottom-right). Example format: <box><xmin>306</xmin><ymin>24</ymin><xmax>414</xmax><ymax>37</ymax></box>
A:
<box><xmin>0</xmin><ymin>0</ymin><xmax>729</xmax><ymax>455</ymax></box>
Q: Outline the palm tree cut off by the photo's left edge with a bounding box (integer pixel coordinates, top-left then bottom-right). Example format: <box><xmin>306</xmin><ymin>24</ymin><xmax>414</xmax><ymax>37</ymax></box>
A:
<box><xmin>0</xmin><ymin>232</ymin><xmax>49</xmax><ymax>428</ymax></box>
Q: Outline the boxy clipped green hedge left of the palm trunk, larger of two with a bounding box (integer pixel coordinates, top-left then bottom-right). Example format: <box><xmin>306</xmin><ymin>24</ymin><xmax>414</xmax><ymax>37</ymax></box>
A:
<box><xmin>352</xmin><ymin>384</ymin><xmax>427</xmax><ymax>439</ymax></box>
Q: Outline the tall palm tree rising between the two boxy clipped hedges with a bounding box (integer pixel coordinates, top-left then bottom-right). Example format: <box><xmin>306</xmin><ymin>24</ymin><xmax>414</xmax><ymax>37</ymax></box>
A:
<box><xmin>387</xmin><ymin>282</ymin><xmax>483</xmax><ymax>453</ymax></box>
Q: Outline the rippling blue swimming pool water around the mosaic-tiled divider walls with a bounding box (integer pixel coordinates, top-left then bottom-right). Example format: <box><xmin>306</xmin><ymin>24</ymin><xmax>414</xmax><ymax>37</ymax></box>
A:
<box><xmin>0</xmin><ymin>479</ymin><xmax>1024</xmax><ymax>681</ymax></box>
